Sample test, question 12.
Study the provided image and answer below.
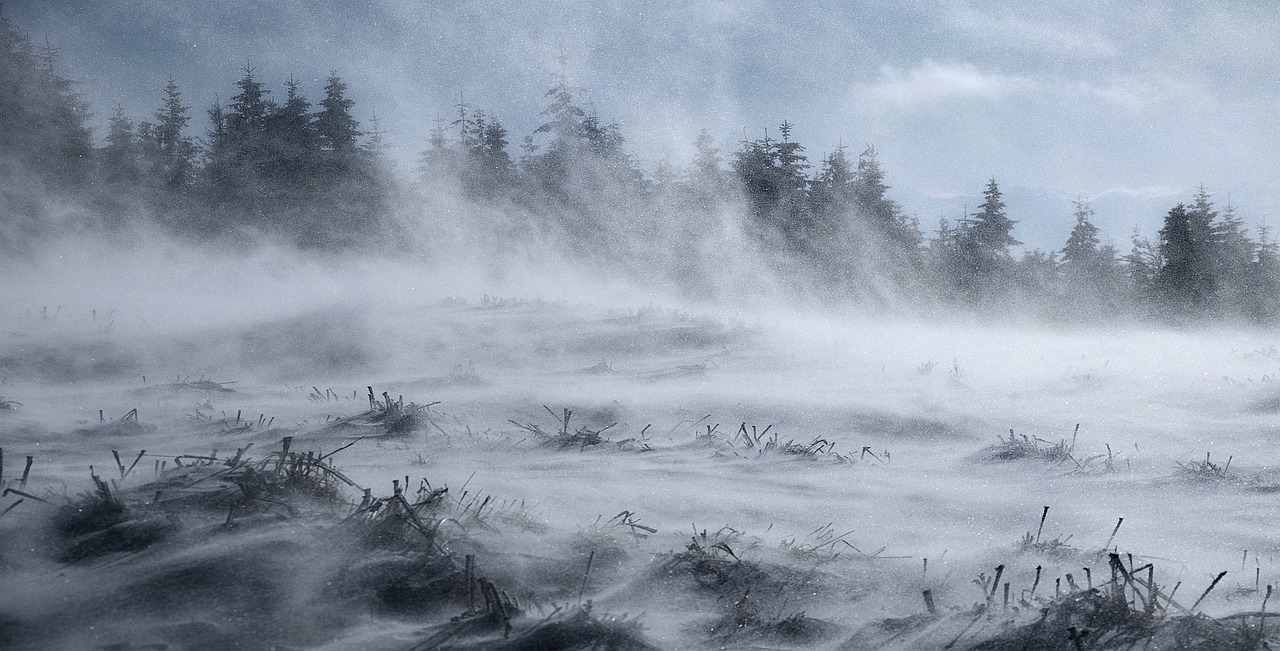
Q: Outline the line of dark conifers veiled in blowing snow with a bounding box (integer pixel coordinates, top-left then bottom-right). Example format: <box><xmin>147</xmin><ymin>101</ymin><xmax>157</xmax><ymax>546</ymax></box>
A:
<box><xmin>0</xmin><ymin>15</ymin><xmax>1280</xmax><ymax>322</ymax></box>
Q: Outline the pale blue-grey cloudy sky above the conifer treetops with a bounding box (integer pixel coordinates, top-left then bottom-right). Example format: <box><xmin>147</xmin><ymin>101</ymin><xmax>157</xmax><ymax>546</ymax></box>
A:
<box><xmin>4</xmin><ymin>0</ymin><xmax>1280</xmax><ymax>249</ymax></box>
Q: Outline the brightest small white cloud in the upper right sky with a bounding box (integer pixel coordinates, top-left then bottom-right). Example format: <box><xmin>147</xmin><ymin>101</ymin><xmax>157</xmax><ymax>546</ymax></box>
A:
<box><xmin>861</xmin><ymin>59</ymin><xmax>1037</xmax><ymax>107</ymax></box>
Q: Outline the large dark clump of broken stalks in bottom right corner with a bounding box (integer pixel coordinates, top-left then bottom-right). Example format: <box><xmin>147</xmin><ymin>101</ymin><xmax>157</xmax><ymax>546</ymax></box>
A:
<box><xmin>851</xmin><ymin>508</ymin><xmax>1272</xmax><ymax>651</ymax></box>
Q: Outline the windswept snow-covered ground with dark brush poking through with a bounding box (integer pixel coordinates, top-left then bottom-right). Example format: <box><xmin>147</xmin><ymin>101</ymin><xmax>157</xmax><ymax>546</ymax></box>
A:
<box><xmin>0</xmin><ymin>281</ymin><xmax>1280</xmax><ymax>648</ymax></box>
